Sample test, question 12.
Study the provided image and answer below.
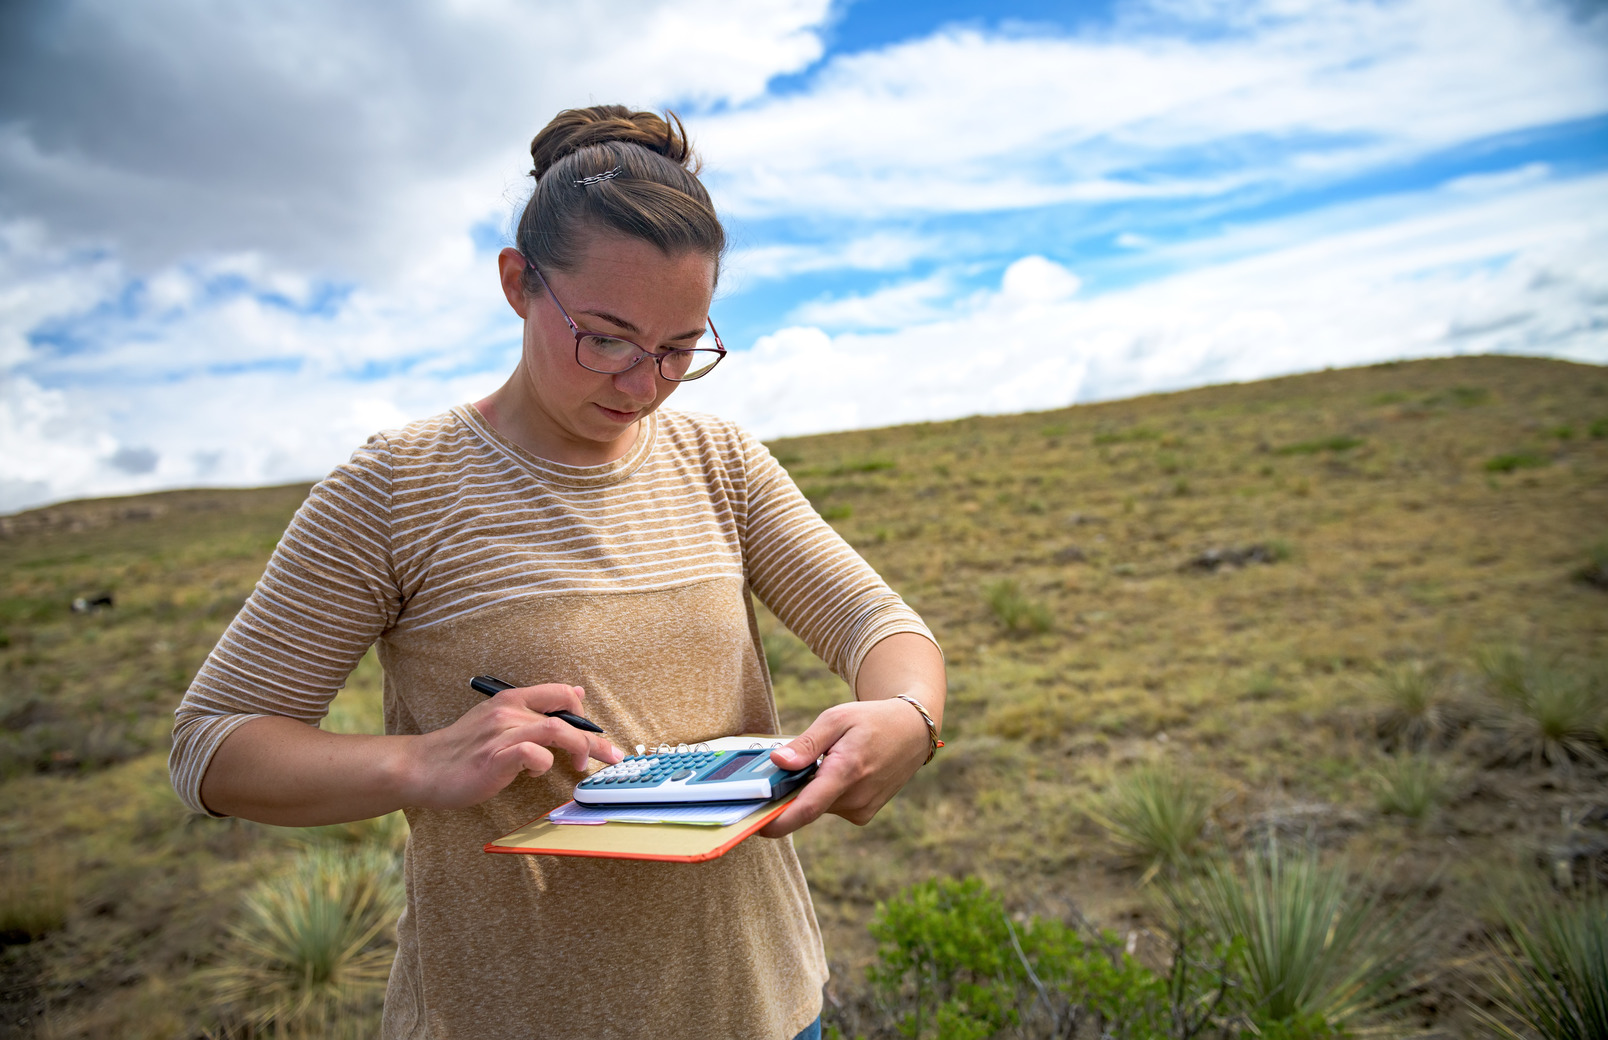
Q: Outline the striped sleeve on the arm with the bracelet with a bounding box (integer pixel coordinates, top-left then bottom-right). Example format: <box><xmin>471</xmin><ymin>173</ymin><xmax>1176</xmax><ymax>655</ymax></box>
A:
<box><xmin>740</xmin><ymin>432</ymin><xmax>937</xmax><ymax>690</ymax></box>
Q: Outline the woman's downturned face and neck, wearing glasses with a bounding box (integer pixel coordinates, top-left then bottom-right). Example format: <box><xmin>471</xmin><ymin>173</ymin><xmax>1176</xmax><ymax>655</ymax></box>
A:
<box><xmin>498</xmin><ymin>233</ymin><xmax>716</xmax><ymax>465</ymax></box>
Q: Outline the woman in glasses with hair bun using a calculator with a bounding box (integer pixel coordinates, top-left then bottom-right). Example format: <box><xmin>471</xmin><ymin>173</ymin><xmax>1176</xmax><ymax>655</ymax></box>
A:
<box><xmin>172</xmin><ymin>106</ymin><xmax>944</xmax><ymax>1040</ymax></box>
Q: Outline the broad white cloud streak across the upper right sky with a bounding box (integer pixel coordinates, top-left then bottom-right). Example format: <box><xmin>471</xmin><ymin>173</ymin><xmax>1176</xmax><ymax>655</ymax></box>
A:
<box><xmin>701</xmin><ymin>0</ymin><xmax>1608</xmax><ymax>217</ymax></box>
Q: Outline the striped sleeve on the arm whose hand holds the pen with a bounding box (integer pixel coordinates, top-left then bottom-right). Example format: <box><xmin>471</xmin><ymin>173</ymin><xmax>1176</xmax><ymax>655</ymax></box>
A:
<box><xmin>167</xmin><ymin>436</ymin><xmax>402</xmax><ymax>817</ymax></box>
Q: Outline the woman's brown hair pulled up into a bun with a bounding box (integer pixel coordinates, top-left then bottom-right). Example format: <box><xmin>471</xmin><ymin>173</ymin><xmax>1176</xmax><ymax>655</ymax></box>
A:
<box><xmin>515</xmin><ymin>104</ymin><xmax>725</xmax><ymax>293</ymax></box>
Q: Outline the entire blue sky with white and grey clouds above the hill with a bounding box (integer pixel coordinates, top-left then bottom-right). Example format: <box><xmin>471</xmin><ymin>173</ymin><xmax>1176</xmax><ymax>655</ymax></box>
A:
<box><xmin>0</xmin><ymin>0</ymin><xmax>1608</xmax><ymax>513</ymax></box>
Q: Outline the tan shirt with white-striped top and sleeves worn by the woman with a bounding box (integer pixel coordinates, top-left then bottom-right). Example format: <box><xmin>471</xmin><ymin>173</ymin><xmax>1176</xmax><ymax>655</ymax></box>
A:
<box><xmin>170</xmin><ymin>407</ymin><xmax>929</xmax><ymax>1038</ymax></box>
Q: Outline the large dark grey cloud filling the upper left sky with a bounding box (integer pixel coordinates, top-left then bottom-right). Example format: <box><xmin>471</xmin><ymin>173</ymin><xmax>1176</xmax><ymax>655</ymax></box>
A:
<box><xmin>0</xmin><ymin>0</ymin><xmax>828</xmax><ymax>280</ymax></box>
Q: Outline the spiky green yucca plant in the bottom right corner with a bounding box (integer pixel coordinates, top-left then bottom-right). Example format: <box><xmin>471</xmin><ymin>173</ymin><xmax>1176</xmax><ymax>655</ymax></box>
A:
<box><xmin>1473</xmin><ymin>887</ymin><xmax>1608</xmax><ymax>1040</ymax></box>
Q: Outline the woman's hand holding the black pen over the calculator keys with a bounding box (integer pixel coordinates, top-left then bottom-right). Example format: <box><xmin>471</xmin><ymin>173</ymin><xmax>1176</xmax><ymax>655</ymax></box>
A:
<box><xmin>404</xmin><ymin>683</ymin><xmax>626</xmax><ymax>809</ymax></box>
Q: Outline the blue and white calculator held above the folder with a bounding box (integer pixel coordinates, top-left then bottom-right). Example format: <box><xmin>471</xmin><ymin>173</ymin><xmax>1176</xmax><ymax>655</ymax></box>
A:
<box><xmin>574</xmin><ymin>747</ymin><xmax>815</xmax><ymax>805</ymax></box>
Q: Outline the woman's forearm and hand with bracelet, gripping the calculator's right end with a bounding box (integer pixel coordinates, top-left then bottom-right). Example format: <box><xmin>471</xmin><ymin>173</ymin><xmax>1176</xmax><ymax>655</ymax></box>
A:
<box><xmin>759</xmin><ymin>633</ymin><xmax>944</xmax><ymax>837</ymax></box>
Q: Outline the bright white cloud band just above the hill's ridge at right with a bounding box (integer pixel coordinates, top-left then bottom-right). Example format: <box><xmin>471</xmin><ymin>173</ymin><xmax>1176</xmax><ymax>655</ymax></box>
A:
<box><xmin>675</xmin><ymin>175</ymin><xmax>1608</xmax><ymax>437</ymax></box>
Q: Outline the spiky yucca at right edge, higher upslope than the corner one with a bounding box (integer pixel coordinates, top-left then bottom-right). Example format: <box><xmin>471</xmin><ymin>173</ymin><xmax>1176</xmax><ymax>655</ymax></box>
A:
<box><xmin>1479</xmin><ymin>649</ymin><xmax>1608</xmax><ymax>767</ymax></box>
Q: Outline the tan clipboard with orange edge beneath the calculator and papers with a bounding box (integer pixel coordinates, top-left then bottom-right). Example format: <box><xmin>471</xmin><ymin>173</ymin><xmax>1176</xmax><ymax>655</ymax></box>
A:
<box><xmin>486</xmin><ymin>791</ymin><xmax>799</xmax><ymax>863</ymax></box>
